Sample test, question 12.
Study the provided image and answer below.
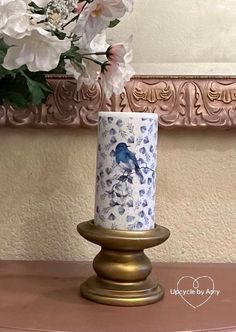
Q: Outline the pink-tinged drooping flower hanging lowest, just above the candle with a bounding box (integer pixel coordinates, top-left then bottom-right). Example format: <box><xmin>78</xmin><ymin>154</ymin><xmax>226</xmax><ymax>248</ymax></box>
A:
<box><xmin>101</xmin><ymin>40</ymin><xmax>134</xmax><ymax>97</ymax></box>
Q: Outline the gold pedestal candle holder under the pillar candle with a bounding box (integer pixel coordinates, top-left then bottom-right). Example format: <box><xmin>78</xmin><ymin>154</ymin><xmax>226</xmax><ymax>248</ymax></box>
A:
<box><xmin>77</xmin><ymin>221</ymin><xmax>170</xmax><ymax>306</ymax></box>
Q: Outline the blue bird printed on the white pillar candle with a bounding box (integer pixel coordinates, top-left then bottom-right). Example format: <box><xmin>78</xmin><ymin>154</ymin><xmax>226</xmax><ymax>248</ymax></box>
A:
<box><xmin>115</xmin><ymin>143</ymin><xmax>144</xmax><ymax>183</ymax></box>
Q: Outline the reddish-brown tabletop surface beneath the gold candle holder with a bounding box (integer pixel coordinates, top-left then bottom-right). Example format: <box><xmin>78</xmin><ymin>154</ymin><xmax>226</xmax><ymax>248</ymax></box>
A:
<box><xmin>0</xmin><ymin>261</ymin><xmax>236</xmax><ymax>332</ymax></box>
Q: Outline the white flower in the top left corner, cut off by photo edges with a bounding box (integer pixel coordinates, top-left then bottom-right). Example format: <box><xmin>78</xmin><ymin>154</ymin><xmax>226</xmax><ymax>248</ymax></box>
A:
<box><xmin>0</xmin><ymin>0</ymin><xmax>30</xmax><ymax>38</ymax></box>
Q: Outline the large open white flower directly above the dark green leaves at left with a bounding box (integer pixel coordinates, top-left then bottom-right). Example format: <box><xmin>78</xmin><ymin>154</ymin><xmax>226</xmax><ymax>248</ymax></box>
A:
<box><xmin>3</xmin><ymin>27</ymin><xmax>71</xmax><ymax>72</ymax></box>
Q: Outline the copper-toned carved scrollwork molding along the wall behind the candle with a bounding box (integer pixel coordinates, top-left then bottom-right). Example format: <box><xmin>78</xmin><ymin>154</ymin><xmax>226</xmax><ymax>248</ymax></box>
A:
<box><xmin>0</xmin><ymin>75</ymin><xmax>236</xmax><ymax>129</ymax></box>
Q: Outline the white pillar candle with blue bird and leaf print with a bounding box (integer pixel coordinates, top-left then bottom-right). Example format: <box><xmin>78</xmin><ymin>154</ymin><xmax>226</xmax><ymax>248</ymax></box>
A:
<box><xmin>94</xmin><ymin>112</ymin><xmax>158</xmax><ymax>231</ymax></box>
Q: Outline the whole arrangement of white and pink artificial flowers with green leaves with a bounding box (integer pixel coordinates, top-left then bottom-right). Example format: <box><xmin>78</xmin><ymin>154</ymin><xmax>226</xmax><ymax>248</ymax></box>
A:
<box><xmin>0</xmin><ymin>0</ymin><xmax>134</xmax><ymax>108</ymax></box>
